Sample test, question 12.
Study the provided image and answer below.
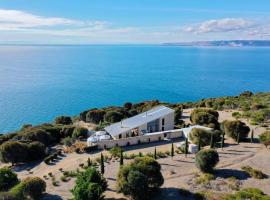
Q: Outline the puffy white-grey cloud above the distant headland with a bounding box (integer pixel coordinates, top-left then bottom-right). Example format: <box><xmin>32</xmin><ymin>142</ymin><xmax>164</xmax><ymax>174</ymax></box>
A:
<box><xmin>184</xmin><ymin>18</ymin><xmax>257</xmax><ymax>34</ymax></box>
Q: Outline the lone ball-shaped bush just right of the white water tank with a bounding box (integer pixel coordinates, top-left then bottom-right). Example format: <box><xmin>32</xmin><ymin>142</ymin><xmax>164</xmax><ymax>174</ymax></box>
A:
<box><xmin>195</xmin><ymin>149</ymin><xmax>219</xmax><ymax>173</ymax></box>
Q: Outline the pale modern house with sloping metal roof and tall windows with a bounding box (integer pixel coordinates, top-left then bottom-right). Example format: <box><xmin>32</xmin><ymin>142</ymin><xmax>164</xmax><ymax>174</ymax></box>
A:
<box><xmin>105</xmin><ymin>106</ymin><xmax>174</xmax><ymax>139</ymax></box>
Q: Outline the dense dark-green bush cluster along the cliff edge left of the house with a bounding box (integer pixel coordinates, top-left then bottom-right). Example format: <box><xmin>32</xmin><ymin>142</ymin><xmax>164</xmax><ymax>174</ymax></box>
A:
<box><xmin>0</xmin><ymin>120</ymin><xmax>88</xmax><ymax>164</ymax></box>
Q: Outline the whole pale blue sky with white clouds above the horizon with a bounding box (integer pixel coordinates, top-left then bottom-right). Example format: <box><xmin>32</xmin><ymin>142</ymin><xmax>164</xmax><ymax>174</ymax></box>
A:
<box><xmin>0</xmin><ymin>0</ymin><xmax>270</xmax><ymax>44</ymax></box>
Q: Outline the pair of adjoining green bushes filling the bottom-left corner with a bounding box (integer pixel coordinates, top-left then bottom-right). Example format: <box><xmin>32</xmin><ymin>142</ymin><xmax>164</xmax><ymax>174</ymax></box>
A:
<box><xmin>0</xmin><ymin>167</ymin><xmax>46</xmax><ymax>200</ymax></box>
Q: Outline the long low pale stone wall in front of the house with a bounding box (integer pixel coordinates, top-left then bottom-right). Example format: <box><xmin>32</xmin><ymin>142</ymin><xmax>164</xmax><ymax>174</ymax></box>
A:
<box><xmin>94</xmin><ymin>129</ymin><xmax>183</xmax><ymax>149</ymax></box>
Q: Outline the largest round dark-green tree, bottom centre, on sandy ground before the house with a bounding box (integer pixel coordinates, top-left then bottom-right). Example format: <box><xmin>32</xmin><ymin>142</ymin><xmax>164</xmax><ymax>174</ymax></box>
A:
<box><xmin>117</xmin><ymin>156</ymin><xmax>164</xmax><ymax>200</ymax></box>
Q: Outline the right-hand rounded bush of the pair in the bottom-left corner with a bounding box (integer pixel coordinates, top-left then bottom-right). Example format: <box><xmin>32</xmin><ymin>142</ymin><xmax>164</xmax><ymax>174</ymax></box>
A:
<box><xmin>11</xmin><ymin>177</ymin><xmax>46</xmax><ymax>200</ymax></box>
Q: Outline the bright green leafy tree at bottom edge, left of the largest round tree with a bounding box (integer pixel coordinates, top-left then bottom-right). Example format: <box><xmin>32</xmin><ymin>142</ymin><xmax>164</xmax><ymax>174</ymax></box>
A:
<box><xmin>72</xmin><ymin>167</ymin><xmax>107</xmax><ymax>200</ymax></box>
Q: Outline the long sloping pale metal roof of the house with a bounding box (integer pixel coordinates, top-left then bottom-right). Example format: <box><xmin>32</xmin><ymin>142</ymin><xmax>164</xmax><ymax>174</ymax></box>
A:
<box><xmin>105</xmin><ymin>106</ymin><xmax>174</xmax><ymax>136</ymax></box>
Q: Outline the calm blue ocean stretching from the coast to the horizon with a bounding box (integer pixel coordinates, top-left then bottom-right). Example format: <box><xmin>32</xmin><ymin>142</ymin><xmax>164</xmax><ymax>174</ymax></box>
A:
<box><xmin>0</xmin><ymin>45</ymin><xmax>270</xmax><ymax>133</ymax></box>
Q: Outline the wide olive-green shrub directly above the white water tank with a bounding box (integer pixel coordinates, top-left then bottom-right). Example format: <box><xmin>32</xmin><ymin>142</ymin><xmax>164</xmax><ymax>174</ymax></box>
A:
<box><xmin>189</xmin><ymin>128</ymin><xmax>221</xmax><ymax>146</ymax></box>
